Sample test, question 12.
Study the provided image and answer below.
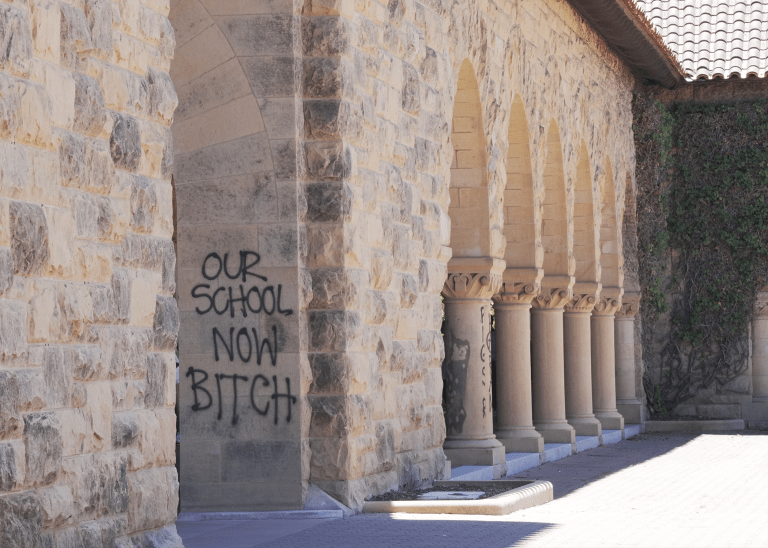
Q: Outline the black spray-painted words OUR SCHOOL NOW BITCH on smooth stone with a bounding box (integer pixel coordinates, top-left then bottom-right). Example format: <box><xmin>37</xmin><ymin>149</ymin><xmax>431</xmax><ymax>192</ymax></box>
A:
<box><xmin>186</xmin><ymin>251</ymin><xmax>296</xmax><ymax>425</ymax></box>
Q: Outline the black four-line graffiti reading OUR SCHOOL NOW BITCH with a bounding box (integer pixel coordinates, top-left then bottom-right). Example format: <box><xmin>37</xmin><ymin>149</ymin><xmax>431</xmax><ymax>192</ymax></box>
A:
<box><xmin>185</xmin><ymin>251</ymin><xmax>297</xmax><ymax>425</ymax></box>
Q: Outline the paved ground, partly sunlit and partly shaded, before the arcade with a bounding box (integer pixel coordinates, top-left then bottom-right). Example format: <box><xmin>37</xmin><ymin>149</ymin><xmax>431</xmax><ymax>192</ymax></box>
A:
<box><xmin>178</xmin><ymin>431</ymin><xmax>768</xmax><ymax>548</ymax></box>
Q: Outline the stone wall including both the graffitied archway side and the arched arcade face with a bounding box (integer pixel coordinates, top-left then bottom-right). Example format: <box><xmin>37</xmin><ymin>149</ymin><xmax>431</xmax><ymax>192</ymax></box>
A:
<box><xmin>170</xmin><ymin>0</ymin><xmax>634</xmax><ymax>510</ymax></box>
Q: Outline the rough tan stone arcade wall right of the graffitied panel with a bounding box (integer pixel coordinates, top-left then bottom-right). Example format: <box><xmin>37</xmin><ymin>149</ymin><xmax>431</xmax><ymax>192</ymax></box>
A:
<box><xmin>300</xmin><ymin>0</ymin><xmax>634</xmax><ymax>505</ymax></box>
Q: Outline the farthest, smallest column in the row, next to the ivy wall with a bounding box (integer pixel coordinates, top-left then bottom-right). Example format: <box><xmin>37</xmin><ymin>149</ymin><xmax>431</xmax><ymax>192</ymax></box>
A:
<box><xmin>615</xmin><ymin>293</ymin><xmax>643</xmax><ymax>424</ymax></box>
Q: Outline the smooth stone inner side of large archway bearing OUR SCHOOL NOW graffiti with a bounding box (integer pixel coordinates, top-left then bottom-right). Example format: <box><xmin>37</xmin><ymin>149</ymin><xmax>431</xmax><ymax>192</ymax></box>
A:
<box><xmin>169</xmin><ymin>0</ymin><xmax>306</xmax><ymax>511</ymax></box>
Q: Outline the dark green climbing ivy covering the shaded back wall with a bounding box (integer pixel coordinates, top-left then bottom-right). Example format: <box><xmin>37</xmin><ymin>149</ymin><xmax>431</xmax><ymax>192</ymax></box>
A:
<box><xmin>635</xmin><ymin>96</ymin><xmax>768</xmax><ymax>415</ymax></box>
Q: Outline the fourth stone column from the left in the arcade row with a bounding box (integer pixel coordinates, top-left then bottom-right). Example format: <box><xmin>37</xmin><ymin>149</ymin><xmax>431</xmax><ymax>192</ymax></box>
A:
<box><xmin>563</xmin><ymin>284</ymin><xmax>602</xmax><ymax>436</ymax></box>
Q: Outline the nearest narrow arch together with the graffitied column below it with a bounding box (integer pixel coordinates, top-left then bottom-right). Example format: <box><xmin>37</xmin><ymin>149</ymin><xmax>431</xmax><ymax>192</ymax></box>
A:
<box><xmin>443</xmin><ymin>60</ymin><xmax>506</xmax><ymax>477</ymax></box>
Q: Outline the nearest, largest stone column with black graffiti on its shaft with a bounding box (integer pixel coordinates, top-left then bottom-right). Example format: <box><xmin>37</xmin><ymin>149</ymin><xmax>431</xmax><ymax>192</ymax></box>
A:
<box><xmin>443</xmin><ymin>259</ymin><xmax>507</xmax><ymax>477</ymax></box>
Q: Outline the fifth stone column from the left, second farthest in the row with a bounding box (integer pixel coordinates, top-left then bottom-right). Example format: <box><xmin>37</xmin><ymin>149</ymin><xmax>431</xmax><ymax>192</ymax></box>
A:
<box><xmin>592</xmin><ymin>288</ymin><xmax>624</xmax><ymax>430</ymax></box>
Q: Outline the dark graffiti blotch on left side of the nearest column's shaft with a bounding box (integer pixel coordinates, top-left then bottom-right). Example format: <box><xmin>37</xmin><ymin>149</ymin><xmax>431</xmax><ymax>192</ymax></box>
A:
<box><xmin>443</xmin><ymin>324</ymin><xmax>471</xmax><ymax>435</ymax></box>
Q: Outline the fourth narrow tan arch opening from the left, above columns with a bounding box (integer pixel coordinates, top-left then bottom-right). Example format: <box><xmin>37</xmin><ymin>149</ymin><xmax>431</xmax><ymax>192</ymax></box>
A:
<box><xmin>573</xmin><ymin>141</ymin><xmax>600</xmax><ymax>282</ymax></box>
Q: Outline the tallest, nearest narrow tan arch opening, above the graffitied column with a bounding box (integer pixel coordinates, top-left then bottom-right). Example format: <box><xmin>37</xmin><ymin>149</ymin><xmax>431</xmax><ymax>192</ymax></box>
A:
<box><xmin>448</xmin><ymin>60</ymin><xmax>491</xmax><ymax>257</ymax></box>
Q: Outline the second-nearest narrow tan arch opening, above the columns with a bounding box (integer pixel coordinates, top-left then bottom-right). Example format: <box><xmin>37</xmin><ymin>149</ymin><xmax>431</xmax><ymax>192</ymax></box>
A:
<box><xmin>504</xmin><ymin>95</ymin><xmax>544</xmax><ymax>268</ymax></box>
